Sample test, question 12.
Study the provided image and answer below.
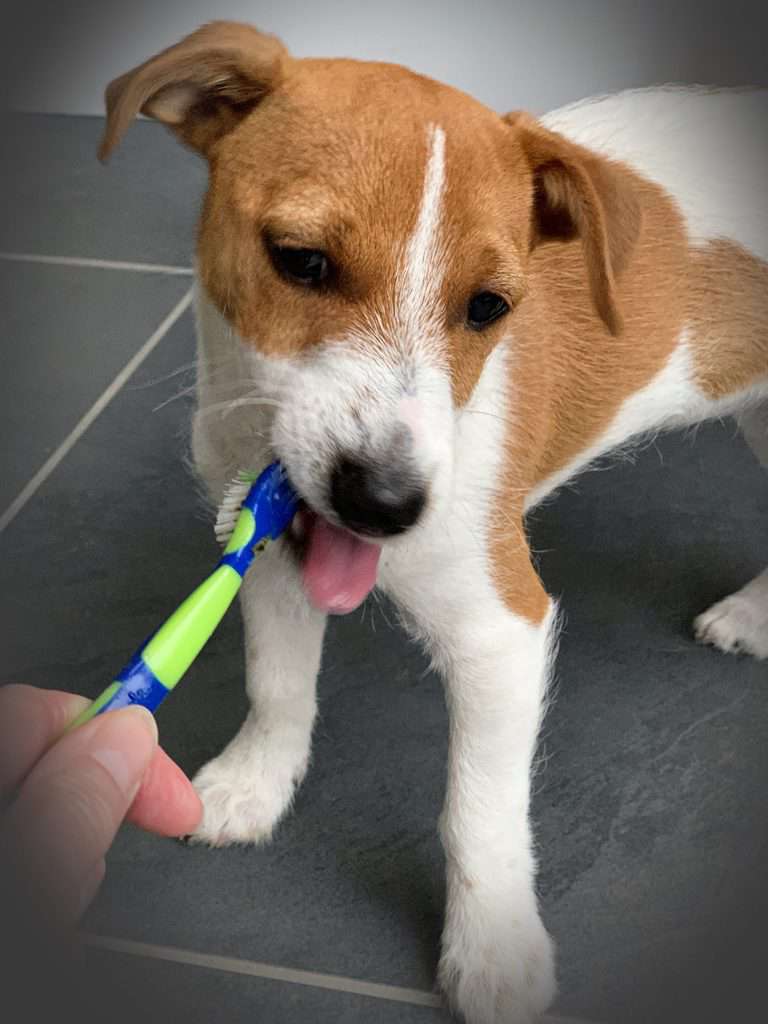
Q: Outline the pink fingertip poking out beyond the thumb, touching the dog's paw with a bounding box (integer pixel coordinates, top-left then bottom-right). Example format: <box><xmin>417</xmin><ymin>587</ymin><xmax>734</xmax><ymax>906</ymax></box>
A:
<box><xmin>128</xmin><ymin>748</ymin><xmax>203</xmax><ymax>836</ymax></box>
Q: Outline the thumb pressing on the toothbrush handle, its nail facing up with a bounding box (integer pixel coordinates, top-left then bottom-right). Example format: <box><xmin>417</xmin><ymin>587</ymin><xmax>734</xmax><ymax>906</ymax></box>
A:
<box><xmin>4</xmin><ymin>707</ymin><xmax>157</xmax><ymax>924</ymax></box>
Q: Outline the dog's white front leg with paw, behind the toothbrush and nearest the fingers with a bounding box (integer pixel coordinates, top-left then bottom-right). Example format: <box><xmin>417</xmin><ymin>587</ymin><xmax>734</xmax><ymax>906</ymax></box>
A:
<box><xmin>193</xmin><ymin>543</ymin><xmax>326</xmax><ymax>846</ymax></box>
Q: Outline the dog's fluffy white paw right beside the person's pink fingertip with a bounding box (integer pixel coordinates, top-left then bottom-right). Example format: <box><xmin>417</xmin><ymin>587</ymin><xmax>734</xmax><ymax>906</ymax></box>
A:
<box><xmin>186</xmin><ymin>751</ymin><xmax>305</xmax><ymax>846</ymax></box>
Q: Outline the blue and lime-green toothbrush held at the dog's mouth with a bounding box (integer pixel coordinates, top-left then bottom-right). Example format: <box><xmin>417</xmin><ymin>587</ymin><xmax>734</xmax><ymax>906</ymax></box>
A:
<box><xmin>69</xmin><ymin>462</ymin><xmax>298</xmax><ymax>729</ymax></box>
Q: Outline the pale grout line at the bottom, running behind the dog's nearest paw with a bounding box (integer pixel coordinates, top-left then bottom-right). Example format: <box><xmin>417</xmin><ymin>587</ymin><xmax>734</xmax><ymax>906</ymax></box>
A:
<box><xmin>78</xmin><ymin>932</ymin><xmax>602</xmax><ymax>1024</ymax></box>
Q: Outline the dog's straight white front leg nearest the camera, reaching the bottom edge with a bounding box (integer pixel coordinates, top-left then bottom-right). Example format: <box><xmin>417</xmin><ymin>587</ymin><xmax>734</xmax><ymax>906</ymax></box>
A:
<box><xmin>393</xmin><ymin>549</ymin><xmax>555</xmax><ymax>1024</ymax></box>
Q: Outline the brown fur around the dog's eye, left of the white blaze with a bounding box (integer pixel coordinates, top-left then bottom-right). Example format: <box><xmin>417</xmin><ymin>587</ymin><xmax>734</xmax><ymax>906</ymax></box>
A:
<box><xmin>199</xmin><ymin>60</ymin><xmax>434</xmax><ymax>355</ymax></box>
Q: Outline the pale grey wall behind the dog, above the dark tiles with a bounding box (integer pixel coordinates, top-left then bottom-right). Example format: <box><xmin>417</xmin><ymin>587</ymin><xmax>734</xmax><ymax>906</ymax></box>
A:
<box><xmin>0</xmin><ymin>0</ymin><xmax>768</xmax><ymax>114</ymax></box>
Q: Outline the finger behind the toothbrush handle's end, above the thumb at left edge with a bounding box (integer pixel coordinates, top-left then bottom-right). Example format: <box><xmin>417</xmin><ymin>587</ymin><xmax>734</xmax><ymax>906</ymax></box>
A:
<box><xmin>0</xmin><ymin>685</ymin><xmax>88</xmax><ymax>799</ymax></box>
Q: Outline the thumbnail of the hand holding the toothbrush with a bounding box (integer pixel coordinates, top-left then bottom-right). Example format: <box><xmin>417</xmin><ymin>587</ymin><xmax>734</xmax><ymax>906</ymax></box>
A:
<box><xmin>90</xmin><ymin>706</ymin><xmax>158</xmax><ymax>798</ymax></box>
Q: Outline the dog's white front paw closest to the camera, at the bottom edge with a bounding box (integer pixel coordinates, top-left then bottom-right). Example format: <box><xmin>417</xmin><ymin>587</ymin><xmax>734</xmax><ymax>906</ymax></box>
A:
<box><xmin>438</xmin><ymin>908</ymin><xmax>557</xmax><ymax>1024</ymax></box>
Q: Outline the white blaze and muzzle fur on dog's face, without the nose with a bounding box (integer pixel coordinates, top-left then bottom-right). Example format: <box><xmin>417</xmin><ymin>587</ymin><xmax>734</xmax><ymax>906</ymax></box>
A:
<box><xmin>272</xmin><ymin>126</ymin><xmax>453</xmax><ymax>519</ymax></box>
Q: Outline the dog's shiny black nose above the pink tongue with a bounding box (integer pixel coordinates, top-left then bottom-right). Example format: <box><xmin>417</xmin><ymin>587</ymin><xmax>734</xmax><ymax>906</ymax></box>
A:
<box><xmin>331</xmin><ymin>457</ymin><xmax>427</xmax><ymax>537</ymax></box>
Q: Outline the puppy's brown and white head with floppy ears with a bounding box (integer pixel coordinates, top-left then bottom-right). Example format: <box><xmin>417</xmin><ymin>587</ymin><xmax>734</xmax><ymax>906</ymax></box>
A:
<box><xmin>101</xmin><ymin>23</ymin><xmax>643</xmax><ymax>610</ymax></box>
